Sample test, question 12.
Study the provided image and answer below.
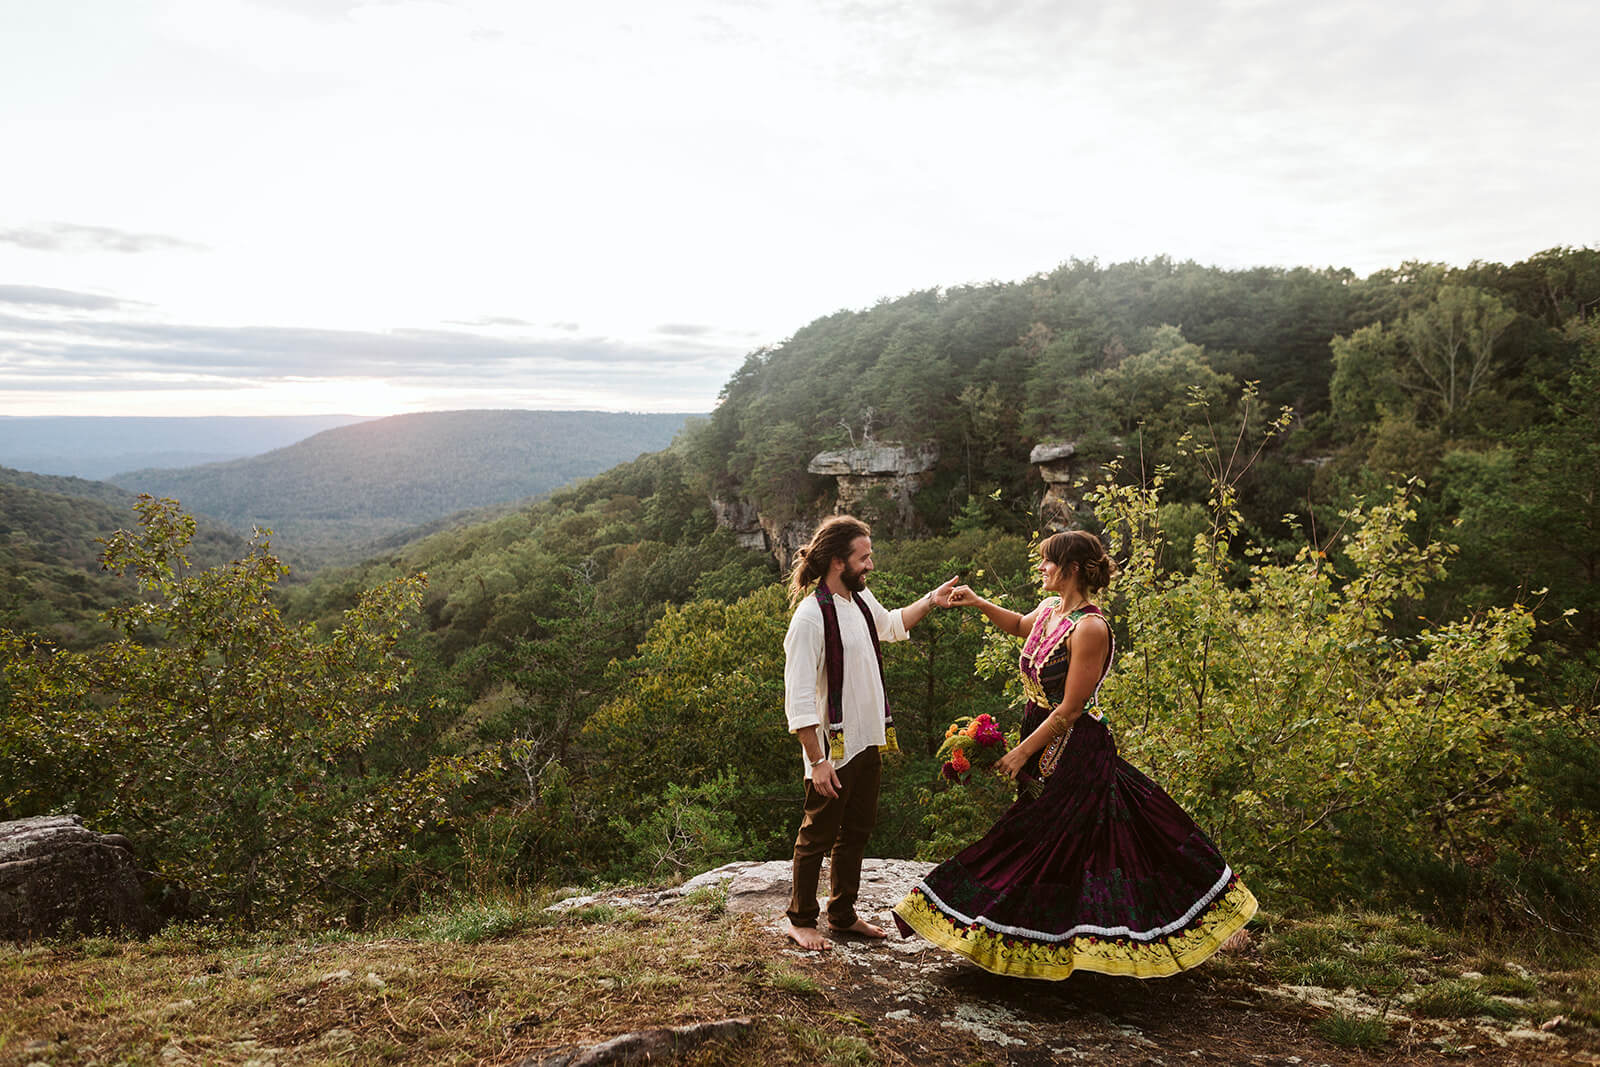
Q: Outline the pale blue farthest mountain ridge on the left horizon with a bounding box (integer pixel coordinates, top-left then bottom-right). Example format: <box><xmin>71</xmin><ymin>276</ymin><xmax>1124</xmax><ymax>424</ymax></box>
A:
<box><xmin>0</xmin><ymin>414</ymin><xmax>366</xmax><ymax>480</ymax></box>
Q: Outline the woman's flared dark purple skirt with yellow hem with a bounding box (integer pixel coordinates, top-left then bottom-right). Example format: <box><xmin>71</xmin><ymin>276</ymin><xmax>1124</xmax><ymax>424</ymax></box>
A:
<box><xmin>894</xmin><ymin>707</ymin><xmax>1256</xmax><ymax>979</ymax></box>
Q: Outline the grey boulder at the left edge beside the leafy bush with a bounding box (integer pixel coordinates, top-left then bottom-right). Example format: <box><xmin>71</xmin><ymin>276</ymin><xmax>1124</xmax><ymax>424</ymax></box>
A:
<box><xmin>0</xmin><ymin>816</ymin><xmax>160</xmax><ymax>941</ymax></box>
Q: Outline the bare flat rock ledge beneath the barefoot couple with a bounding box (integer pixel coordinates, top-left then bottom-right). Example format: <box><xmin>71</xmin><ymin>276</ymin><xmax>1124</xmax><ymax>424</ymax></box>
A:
<box><xmin>557</xmin><ymin>861</ymin><xmax>1600</xmax><ymax>1067</ymax></box>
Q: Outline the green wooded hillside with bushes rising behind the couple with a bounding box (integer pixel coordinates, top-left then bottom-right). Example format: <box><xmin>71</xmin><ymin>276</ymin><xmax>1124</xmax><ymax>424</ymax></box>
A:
<box><xmin>0</xmin><ymin>250</ymin><xmax>1600</xmax><ymax>936</ymax></box>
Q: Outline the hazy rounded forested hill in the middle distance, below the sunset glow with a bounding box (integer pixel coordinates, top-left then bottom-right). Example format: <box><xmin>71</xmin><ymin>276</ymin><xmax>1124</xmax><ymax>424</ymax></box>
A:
<box><xmin>106</xmin><ymin>411</ymin><xmax>688</xmax><ymax>565</ymax></box>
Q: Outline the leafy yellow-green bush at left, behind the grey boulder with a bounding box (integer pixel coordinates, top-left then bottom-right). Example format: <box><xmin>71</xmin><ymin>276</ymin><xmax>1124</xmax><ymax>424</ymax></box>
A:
<box><xmin>0</xmin><ymin>498</ymin><xmax>483</xmax><ymax>923</ymax></box>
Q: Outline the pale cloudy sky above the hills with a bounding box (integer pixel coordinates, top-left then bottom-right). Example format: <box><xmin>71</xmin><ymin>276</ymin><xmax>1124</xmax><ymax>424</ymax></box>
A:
<box><xmin>0</xmin><ymin>0</ymin><xmax>1600</xmax><ymax>416</ymax></box>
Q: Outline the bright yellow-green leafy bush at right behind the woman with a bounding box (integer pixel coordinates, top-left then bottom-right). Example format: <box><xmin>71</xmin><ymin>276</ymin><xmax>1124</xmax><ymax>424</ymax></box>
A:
<box><xmin>1056</xmin><ymin>399</ymin><xmax>1600</xmax><ymax>931</ymax></box>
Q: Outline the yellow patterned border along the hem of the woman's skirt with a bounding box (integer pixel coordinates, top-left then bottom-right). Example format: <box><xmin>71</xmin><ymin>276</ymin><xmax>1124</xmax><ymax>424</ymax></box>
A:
<box><xmin>894</xmin><ymin>878</ymin><xmax>1258</xmax><ymax>981</ymax></box>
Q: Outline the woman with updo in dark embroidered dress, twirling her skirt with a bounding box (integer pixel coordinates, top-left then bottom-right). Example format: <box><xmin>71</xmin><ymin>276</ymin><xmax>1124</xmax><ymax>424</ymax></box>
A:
<box><xmin>894</xmin><ymin>530</ymin><xmax>1256</xmax><ymax>979</ymax></box>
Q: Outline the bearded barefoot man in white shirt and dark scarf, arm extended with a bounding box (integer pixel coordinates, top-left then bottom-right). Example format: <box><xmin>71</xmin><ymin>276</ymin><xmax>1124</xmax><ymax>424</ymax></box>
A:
<box><xmin>784</xmin><ymin>515</ymin><xmax>955</xmax><ymax>952</ymax></box>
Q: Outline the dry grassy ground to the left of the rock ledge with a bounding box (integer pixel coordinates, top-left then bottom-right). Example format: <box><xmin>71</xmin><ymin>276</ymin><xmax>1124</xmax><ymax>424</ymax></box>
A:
<box><xmin>0</xmin><ymin>899</ymin><xmax>880</xmax><ymax>1067</ymax></box>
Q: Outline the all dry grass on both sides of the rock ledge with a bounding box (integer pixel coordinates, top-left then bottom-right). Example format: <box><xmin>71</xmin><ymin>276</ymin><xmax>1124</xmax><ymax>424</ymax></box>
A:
<box><xmin>0</xmin><ymin>891</ymin><xmax>1600</xmax><ymax>1067</ymax></box>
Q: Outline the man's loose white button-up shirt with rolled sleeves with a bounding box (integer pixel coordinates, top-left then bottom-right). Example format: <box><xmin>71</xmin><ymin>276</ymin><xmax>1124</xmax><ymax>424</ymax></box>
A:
<box><xmin>784</xmin><ymin>590</ymin><xmax>907</xmax><ymax>777</ymax></box>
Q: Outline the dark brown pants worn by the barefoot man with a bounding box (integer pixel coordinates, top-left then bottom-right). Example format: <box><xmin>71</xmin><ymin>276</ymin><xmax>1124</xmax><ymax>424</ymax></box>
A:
<box><xmin>789</xmin><ymin>749</ymin><xmax>883</xmax><ymax>929</ymax></box>
